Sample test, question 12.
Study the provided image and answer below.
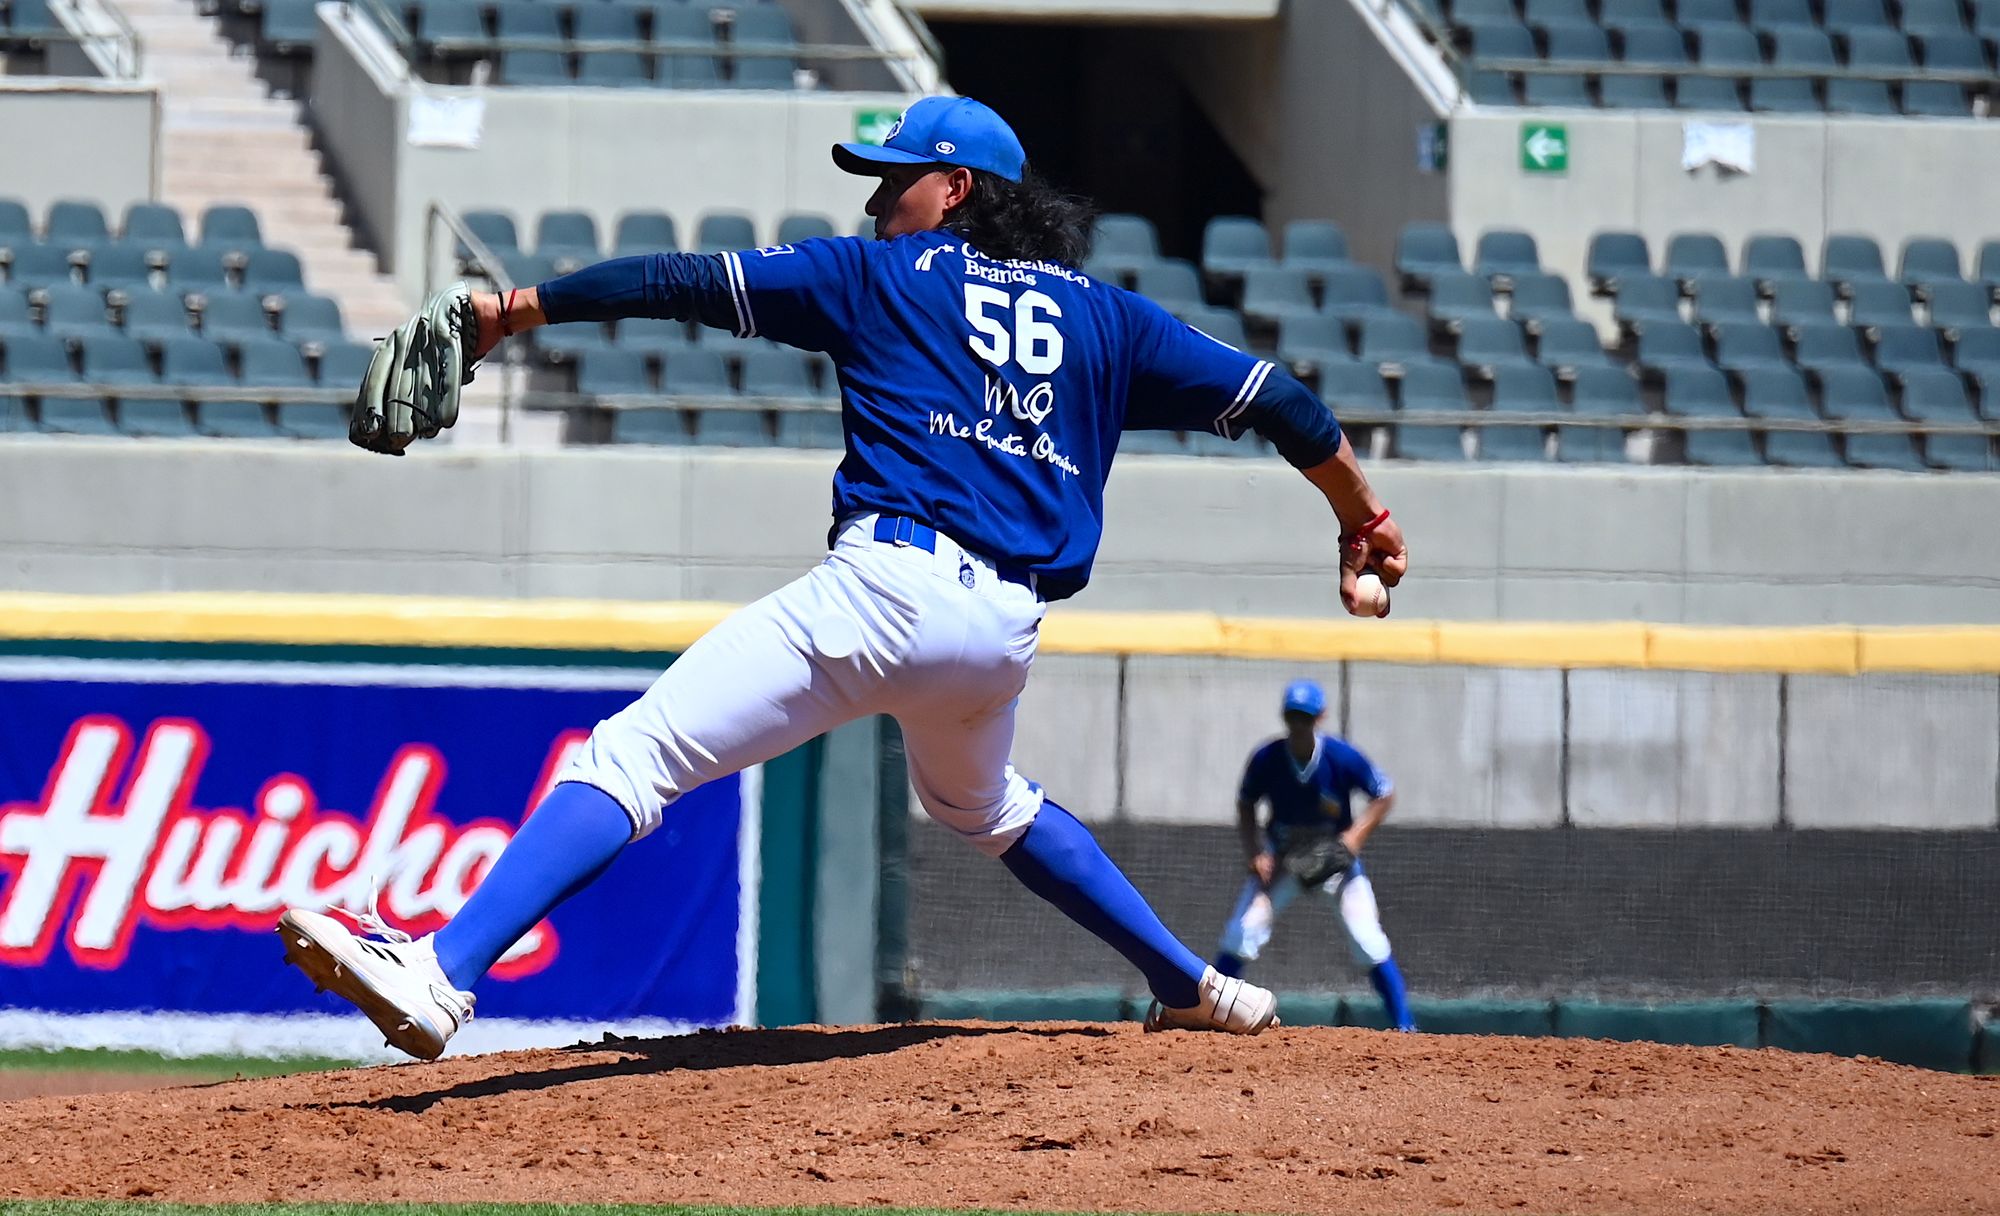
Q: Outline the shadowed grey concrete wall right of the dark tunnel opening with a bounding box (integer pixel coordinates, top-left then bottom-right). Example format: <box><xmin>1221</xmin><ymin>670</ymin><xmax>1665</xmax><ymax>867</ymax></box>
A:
<box><xmin>1164</xmin><ymin>0</ymin><xmax>1448</xmax><ymax>266</ymax></box>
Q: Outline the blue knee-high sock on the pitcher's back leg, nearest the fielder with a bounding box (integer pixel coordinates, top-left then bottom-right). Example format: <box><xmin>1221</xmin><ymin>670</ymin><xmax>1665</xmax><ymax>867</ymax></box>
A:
<box><xmin>1000</xmin><ymin>800</ymin><xmax>1206</xmax><ymax>1010</ymax></box>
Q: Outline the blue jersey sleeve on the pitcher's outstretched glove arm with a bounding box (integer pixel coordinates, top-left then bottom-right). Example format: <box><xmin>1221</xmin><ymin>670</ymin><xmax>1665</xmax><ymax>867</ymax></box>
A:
<box><xmin>722</xmin><ymin>236</ymin><xmax>870</xmax><ymax>350</ymax></box>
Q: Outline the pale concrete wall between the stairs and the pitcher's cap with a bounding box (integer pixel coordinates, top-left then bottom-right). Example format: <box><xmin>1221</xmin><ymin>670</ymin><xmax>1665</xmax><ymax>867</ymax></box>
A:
<box><xmin>312</xmin><ymin>6</ymin><xmax>908</xmax><ymax>300</ymax></box>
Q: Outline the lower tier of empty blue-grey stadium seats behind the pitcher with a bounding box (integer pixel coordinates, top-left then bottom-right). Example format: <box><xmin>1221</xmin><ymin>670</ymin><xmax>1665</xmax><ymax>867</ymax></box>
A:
<box><xmin>11</xmin><ymin>197</ymin><xmax>2000</xmax><ymax>472</ymax></box>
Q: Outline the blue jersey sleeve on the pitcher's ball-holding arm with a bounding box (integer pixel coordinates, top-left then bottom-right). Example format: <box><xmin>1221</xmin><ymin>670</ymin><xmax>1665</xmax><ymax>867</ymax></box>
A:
<box><xmin>1126</xmin><ymin>296</ymin><xmax>1274</xmax><ymax>438</ymax></box>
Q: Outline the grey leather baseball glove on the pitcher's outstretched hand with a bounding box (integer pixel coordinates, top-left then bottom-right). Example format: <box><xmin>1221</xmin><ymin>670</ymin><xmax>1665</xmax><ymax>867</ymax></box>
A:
<box><xmin>348</xmin><ymin>282</ymin><xmax>480</xmax><ymax>456</ymax></box>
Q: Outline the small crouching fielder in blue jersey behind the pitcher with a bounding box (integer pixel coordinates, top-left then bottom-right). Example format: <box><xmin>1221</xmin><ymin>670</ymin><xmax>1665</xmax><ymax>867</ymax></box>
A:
<box><xmin>1214</xmin><ymin>680</ymin><xmax>1416</xmax><ymax>1030</ymax></box>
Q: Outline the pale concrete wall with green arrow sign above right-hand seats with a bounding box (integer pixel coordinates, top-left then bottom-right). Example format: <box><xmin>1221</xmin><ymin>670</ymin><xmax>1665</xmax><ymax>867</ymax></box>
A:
<box><xmin>1456</xmin><ymin>108</ymin><xmax>2000</xmax><ymax>304</ymax></box>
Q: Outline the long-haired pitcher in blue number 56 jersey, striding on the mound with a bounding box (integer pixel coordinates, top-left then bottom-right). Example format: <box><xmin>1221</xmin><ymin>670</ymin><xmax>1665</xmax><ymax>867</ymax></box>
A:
<box><xmin>278</xmin><ymin>98</ymin><xmax>1408</xmax><ymax>1058</ymax></box>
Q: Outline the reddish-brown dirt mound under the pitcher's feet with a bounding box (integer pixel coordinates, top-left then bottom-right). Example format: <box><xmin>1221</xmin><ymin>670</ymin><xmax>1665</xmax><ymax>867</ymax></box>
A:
<box><xmin>0</xmin><ymin>1022</ymin><xmax>2000</xmax><ymax>1216</ymax></box>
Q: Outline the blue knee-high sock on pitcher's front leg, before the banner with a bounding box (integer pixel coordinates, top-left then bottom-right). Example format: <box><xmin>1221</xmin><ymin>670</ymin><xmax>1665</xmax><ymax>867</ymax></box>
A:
<box><xmin>434</xmin><ymin>782</ymin><xmax>632</xmax><ymax>988</ymax></box>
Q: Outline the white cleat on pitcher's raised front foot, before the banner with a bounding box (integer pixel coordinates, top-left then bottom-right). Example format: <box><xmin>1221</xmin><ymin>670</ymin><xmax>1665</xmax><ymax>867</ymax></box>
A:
<box><xmin>278</xmin><ymin>908</ymin><xmax>472</xmax><ymax>1060</ymax></box>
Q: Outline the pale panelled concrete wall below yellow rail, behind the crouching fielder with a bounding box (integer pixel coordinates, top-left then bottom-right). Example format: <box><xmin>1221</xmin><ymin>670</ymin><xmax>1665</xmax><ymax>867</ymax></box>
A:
<box><xmin>940</xmin><ymin>654</ymin><xmax>2000</xmax><ymax>830</ymax></box>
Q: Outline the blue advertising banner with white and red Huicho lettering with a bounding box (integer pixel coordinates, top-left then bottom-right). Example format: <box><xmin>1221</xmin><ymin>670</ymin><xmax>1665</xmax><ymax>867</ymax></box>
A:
<box><xmin>0</xmin><ymin>658</ymin><xmax>758</xmax><ymax>1046</ymax></box>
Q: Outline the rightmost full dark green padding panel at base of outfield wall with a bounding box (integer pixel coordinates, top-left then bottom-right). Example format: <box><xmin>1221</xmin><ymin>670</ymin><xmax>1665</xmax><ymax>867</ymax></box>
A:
<box><xmin>1764</xmin><ymin>998</ymin><xmax>1974</xmax><ymax>1072</ymax></box>
